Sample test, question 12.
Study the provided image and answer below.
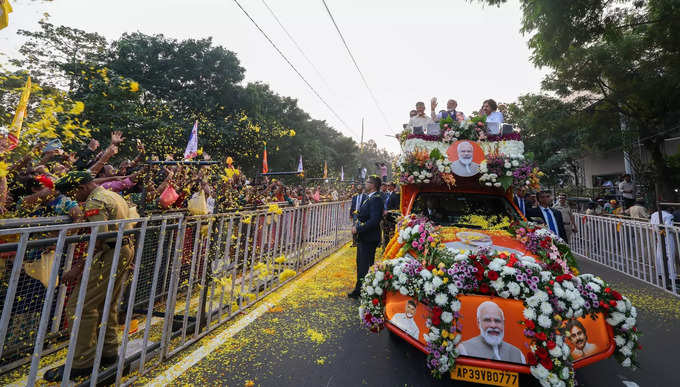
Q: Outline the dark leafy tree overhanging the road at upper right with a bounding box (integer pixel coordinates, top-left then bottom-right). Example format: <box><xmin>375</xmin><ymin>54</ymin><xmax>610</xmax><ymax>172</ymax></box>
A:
<box><xmin>484</xmin><ymin>0</ymin><xmax>680</xmax><ymax>196</ymax></box>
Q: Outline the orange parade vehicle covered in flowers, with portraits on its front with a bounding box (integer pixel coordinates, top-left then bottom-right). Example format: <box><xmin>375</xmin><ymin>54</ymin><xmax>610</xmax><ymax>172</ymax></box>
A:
<box><xmin>360</xmin><ymin>125</ymin><xmax>640</xmax><ymax>386</ymax></box>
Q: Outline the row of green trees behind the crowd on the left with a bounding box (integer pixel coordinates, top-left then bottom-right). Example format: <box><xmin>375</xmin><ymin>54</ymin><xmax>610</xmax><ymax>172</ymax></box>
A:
<box><xmin>0</xmin><ymin>21</ymin><xmax>394</xmax><ymax>179</ymax></box>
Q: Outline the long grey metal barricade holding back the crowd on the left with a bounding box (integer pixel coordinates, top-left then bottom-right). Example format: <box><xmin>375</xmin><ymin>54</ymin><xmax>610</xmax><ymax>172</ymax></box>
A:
<box><xmin>0</xmin><ymin>201</ymin><xmax>351</xmax><ymax>386</ymax></box>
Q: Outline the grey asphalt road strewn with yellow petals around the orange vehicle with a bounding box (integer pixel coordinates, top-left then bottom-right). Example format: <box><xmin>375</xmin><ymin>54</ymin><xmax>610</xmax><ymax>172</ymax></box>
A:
<box><xmin>163</xmin><ymin>248</ymin><xmax>680</xmax><ymax>387</ymax></box>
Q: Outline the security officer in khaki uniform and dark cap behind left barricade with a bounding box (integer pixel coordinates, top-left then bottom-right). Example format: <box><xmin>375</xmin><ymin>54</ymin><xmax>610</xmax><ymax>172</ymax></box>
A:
<box><xmin>44</xmin><ymin>171</ymin><xmax>134</xmax><ymax>382</ymax></box>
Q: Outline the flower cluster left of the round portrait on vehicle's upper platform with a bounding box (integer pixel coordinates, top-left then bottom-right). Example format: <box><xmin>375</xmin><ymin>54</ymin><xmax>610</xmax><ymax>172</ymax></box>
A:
<box><xmin>399</xmin><ymin>148</ymin><xmax>456</xmax><ymax>187</ymax></box>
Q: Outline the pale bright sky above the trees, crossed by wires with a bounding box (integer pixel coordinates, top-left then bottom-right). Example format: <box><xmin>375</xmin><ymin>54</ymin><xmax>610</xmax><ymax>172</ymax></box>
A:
<box><xmin>0</xmin><ymin>0</ymin><xmax>546</xmax><ymax>153</ymax></box>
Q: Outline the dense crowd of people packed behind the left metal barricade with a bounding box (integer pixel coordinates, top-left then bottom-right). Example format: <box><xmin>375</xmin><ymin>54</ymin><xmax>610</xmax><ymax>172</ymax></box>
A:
<box><xmin>0</xmin><ymin>132</ymin><xmax>362</xmax><ymax>221</ymax></box>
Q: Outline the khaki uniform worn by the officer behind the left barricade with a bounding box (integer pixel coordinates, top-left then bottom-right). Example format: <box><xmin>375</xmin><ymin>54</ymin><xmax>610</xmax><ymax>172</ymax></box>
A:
<box><xmin>66</xmin><ymin>187</ymin><xmax>134</xmax><ymax>368</ymax></box>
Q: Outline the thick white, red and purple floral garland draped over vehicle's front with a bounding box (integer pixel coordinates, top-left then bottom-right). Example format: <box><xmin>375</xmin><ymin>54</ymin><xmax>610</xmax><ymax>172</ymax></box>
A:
<box><xmin>359</xmin><ymin>215</ymin><xmax>641</xmax><ymax>386</ymax></box>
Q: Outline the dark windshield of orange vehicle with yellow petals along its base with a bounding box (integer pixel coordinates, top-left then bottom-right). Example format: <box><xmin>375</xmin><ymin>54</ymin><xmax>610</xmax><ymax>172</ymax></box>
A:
<box><xmin>411</xmin><ymin>192</ymin><xmax>521</xmax><ymax>229</ymax></box>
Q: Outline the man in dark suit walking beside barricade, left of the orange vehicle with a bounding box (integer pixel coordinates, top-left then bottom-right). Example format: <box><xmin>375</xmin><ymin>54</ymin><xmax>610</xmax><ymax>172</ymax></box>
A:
<box><xmin>347</xmin><ymin>175</ymin><xmax>384</xmax><ymax>298</ymax></box>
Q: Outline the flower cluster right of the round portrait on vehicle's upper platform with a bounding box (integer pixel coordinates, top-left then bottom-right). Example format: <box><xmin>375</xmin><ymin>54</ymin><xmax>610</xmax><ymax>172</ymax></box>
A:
<box><xmin>479</xmin><ymin>154</ymin><xmax>543</xmax><ymax>189</ymax></box>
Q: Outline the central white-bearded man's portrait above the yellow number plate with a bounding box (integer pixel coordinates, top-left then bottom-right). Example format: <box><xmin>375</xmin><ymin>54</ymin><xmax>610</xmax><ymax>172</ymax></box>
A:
<box><xmin>458</xmin><ymin>301</ymin><xmax>526</xmax><ymax>364</ymax></box>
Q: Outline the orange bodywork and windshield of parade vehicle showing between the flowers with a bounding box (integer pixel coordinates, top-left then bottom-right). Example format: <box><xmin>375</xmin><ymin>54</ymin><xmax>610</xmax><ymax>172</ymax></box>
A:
<box><xmin>385</xmin><ymin>183</ymin><xmax>616</xmax><ymax>385</ymax></box>
